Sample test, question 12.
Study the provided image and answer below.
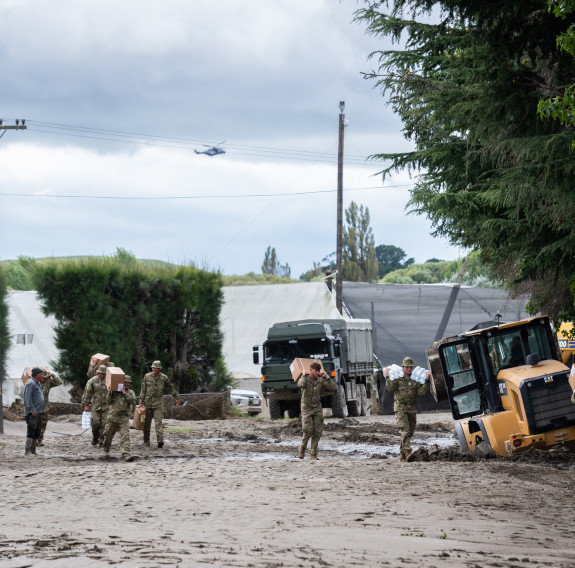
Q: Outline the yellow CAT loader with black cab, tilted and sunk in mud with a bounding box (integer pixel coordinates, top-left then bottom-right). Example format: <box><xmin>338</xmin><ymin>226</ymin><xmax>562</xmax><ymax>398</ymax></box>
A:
<box><xmin>427</xmin><ymin>316</ymin><xmax>575</xmax><ymax>456</ymax></box>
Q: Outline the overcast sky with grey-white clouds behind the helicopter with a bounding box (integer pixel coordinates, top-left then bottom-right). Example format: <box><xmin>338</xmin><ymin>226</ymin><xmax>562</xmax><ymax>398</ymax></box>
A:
<box><xmin>0</xmin><ymin>0</ymin><xmax>462</xmax><ymax>277</ymax></box>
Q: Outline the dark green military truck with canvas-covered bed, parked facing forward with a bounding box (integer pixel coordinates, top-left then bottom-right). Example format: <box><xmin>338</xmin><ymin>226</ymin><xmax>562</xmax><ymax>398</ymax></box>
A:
<box><xmin>253</xmin><ymin>319</ymin><xmax>373</xmax><ymax>420</ymax></box>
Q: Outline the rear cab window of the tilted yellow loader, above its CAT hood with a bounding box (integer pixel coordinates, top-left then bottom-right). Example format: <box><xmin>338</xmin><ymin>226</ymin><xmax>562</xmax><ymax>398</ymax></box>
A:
<box><xmin>487</xmin><ymin>326</ymin><xmax>552</xmax><ymax>375</ymax></box>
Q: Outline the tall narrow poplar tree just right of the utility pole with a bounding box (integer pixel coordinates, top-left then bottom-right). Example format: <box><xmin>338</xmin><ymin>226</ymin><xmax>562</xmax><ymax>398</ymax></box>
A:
<box><xmin>342</xmin><ymin>201</ymin><xmax>378</xmax><ymax>282</ymax></box>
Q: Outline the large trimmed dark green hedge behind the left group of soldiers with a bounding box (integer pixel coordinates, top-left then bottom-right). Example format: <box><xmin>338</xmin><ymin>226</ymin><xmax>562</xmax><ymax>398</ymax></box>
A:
<box><xmin>35</xmin><ymin>257</ymin><xmax>232</xmax><ymax>392</ymax></box>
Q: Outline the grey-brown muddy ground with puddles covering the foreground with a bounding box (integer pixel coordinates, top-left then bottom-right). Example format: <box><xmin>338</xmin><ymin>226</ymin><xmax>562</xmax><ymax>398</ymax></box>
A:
<box><xmin>0</xmin><ymin>414</ymin><xmax>575</xmax><ymax>568</ymax></box>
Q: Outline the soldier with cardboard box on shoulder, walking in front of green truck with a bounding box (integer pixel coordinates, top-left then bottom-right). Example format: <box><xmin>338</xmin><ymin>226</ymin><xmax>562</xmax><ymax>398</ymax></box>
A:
<box><xmin>297</xmin><ymin>363</ymin><xmax>337</xmax><ymax>460</ymax></box>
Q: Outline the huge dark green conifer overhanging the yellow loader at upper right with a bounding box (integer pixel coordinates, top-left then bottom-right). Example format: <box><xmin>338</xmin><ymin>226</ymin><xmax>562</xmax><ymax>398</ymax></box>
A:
<box><xmin>356</xmin><ymin>0</ymin><xmax>575</xmax><ymax>319</ymax></box>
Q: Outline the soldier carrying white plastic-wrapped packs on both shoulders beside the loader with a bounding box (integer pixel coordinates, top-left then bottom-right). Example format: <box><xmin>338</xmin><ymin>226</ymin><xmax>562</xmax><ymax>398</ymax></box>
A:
<box><xmin>383</xmin><ymin>357</ymin><xmax>431</xmax><ymax>462</ymax></box>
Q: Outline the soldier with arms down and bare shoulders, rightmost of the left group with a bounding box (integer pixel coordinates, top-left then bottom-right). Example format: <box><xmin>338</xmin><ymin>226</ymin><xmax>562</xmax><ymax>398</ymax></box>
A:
<box><xmin>140</xmin><ymin>361</ymin><xmax>180</xmax><ymax>448</ymax></box>
